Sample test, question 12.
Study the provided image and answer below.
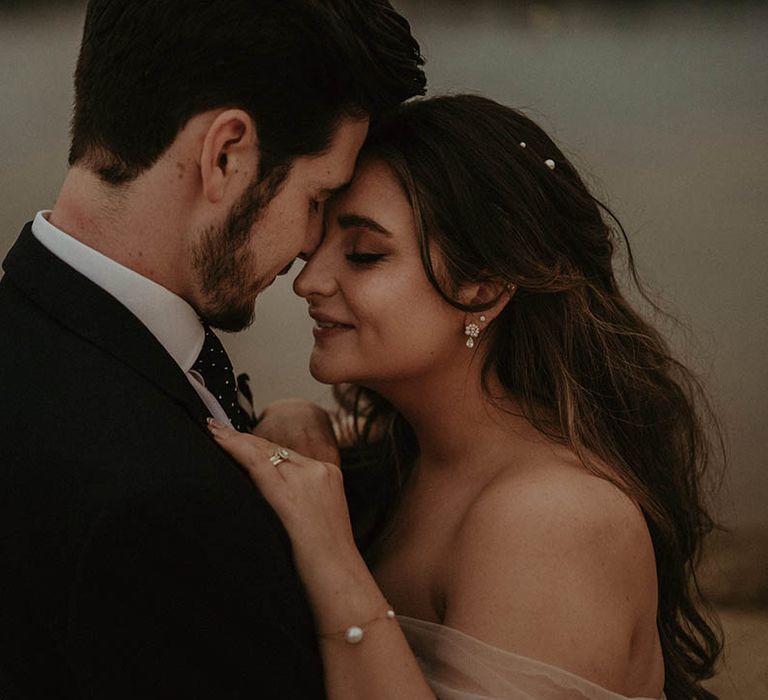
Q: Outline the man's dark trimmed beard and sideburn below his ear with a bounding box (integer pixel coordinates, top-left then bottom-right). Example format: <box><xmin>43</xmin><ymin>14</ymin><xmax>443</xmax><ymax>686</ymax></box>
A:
<box><xmin>192</xmin><ymin>172</ymin><xmax>276</xmax><ymax>331</ymax></box>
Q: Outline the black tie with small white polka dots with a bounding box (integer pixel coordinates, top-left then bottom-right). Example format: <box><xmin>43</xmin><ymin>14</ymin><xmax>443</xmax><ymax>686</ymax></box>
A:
<box><xmin>192</xmin><ymin>324</ymin><xmax>255</xmax><ymax>431</ymax></box>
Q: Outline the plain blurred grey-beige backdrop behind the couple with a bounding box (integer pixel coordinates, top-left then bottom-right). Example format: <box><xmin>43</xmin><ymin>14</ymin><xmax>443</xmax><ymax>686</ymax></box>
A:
<box><xmin>0</xmin><ymin>0</ymin><xmax>768</xmax><ymax>697</ymax></box>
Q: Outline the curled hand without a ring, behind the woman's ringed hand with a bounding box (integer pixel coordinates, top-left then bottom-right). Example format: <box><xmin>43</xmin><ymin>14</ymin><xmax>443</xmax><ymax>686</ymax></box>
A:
<box><xmin>253</xmin><ymin>399</ymin><xmax>340</xmax><ymax>464</ymax></box>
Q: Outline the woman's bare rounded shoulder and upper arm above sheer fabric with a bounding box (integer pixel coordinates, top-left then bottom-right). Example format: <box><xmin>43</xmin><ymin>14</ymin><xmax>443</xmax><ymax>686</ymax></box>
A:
<box><xmin>446</xmin><ymin>457</ymin><xmax>656</xmax><ymax>690</ymax></box>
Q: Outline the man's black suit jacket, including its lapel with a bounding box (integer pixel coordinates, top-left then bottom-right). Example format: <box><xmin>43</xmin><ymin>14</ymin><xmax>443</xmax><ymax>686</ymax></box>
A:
<box><xmin>0</xmin><ymin>225</ymin><xmax>323</xmax><ymax>700</ymax></box>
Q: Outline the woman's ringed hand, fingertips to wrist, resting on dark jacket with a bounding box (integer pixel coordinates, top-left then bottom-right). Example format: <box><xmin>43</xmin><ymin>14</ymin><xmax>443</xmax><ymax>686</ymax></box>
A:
<box><xmin>209</xmin><ymin>420</ymin><xmax>359</xmax><ymax>572</ymax></box>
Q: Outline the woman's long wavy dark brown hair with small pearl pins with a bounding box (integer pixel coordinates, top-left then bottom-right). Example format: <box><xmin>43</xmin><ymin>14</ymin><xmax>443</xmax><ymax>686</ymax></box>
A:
<box><xmin>336</xmin><ymin>95</ymin><xmax>724</xmax><ymax>700</ymax></box>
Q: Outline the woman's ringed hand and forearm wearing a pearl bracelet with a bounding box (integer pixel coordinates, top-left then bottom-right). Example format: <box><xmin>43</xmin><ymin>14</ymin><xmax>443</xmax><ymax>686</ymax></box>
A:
<box><xmin>208</xmin><ymin>420</ymin><xmax>435</xmax><ymax>700</ymax></box>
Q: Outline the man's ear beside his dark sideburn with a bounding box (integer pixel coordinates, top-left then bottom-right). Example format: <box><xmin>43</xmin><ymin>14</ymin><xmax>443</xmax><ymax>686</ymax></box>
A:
<box><xmin>200</xmin><ymin>109</ymin><xmax>259</xmax><ymax>204</ymax></box>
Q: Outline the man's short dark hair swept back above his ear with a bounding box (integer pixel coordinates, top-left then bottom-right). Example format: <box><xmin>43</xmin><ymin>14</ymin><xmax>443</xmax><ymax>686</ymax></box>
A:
<box><xmin>69</xmin><ymin>0</ymin><xmax>426</xmax><ymax>185</ymax></box>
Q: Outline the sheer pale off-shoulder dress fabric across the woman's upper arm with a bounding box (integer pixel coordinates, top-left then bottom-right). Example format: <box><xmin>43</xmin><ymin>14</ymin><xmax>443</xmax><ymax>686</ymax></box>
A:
<box><xmin>397</xmin><ymin>615</ymin><xmax>664</xmax><ymax>700</ymax></box>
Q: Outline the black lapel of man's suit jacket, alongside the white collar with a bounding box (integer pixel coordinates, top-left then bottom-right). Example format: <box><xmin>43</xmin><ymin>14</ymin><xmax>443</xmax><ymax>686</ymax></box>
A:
<box><xmin>3</xmin><ymin>223</ymin><xmax>210</xmax><ymax>426</ymax></box>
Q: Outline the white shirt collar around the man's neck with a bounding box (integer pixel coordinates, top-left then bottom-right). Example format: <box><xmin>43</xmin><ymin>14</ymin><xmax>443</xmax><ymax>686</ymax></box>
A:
<box><xmin>32</xmin><ymin>211</ymin><xmax>205</xmax><ymax>372</ymax></box>
